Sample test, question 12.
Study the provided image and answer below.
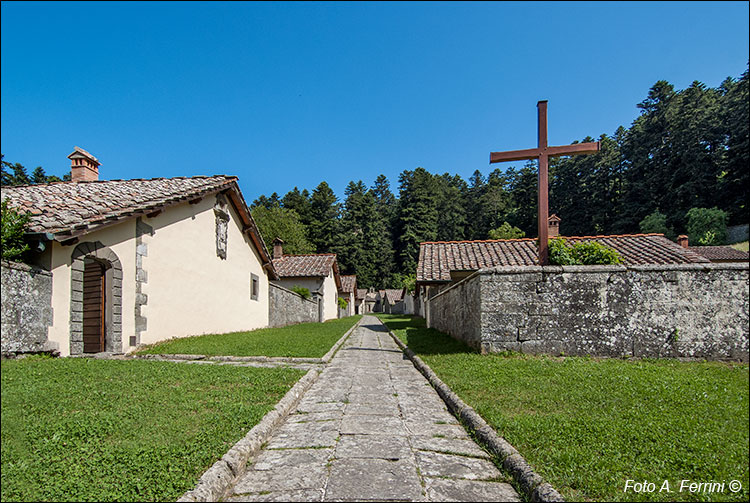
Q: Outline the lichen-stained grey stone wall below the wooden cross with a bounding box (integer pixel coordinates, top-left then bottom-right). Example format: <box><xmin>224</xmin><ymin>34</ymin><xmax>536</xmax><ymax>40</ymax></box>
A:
<box><xmin>428</xmin><ymin>264</ymin><xmax>750</xmax><ymax>361</ymax></box>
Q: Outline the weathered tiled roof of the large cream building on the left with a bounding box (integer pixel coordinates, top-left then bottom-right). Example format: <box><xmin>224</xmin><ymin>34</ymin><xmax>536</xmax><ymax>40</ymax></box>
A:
<box><xmin>2</xmin><ymin>175</ymin><xmax>237</xmax><ymax>238</ymax></box>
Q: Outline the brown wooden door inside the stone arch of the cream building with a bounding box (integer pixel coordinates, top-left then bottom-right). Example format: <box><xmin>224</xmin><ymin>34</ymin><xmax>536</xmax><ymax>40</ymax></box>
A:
<box><xmin>83</xmin><ymin>258</ymin><xmax>106</xmax><ymax>353</ymax></box>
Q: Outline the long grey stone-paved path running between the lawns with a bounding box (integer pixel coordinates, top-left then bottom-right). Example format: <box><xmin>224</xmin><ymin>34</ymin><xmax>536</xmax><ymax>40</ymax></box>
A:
<box><xmin>227</xmin><ymin>316</ymin><xmax>520</xmax><ymax>501</ymax></box>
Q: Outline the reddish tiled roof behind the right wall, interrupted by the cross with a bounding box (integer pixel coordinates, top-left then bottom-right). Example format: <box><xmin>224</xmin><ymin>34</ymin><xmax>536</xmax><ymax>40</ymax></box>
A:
<box><xmin>417</xmin><ymin>234</ymin><xmax>708</xmax><ymax>282</ymax></box>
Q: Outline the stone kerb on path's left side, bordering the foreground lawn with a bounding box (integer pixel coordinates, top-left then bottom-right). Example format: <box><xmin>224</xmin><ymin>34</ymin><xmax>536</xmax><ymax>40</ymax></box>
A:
<box><xmin>177</xmin><ymin>369</ymin><xmax>320</xmax><ymax>502</ymax></box>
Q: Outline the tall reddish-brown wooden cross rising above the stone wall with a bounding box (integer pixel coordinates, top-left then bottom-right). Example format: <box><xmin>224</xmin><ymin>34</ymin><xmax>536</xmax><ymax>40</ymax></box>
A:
<box><xmin>490</xmin><ymin>100</ymin><xmax>600</xmax><ymax>265</ymax></box>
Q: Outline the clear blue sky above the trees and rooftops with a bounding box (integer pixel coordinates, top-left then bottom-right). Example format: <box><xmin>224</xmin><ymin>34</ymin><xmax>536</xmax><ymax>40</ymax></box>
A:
<box><xmin>0</xmin><ymin>2</ymin><xmax>750</xmax><ymax>203</ymax></box>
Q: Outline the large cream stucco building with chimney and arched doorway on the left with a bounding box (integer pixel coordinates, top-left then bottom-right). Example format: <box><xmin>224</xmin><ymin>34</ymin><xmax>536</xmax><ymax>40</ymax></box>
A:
<box><xmin>2</xmin><ymin>147</ymin><xmax>277</xmax><ymax>356</ymax></box>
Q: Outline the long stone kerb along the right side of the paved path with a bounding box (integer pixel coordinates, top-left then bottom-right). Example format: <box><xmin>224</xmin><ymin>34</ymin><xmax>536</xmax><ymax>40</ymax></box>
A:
<box><xmin>381</xmin><ymin>321</ymin><xmax>565</xmax><ymax>502</ymax></box>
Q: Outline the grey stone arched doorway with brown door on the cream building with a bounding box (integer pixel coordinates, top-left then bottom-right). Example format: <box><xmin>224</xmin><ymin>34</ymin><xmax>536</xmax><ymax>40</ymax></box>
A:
<box><xmin>70</xmin><ymin>241</ymin><xmax>122</xmax><ymax>355</ymax></box>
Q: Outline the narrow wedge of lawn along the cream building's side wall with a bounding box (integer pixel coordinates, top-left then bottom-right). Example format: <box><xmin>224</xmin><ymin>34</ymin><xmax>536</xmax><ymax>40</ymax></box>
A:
<box><xmin>137</xmin><ymin>315</ymin><xmax>362</xmax><ymax>358</ymax></box>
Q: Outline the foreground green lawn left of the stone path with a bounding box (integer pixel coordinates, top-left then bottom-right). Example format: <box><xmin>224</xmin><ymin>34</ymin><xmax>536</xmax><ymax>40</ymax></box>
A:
<box><xmin>0</xmin><ymin>358</ymin><xmax>304</xmax><ymax>501</ymax></box>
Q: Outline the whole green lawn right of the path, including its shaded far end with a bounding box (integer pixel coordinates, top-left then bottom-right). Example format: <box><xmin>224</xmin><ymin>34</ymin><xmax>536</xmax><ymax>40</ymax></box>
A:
<box><xmin>379</xmin><ymin>315</ymin><xmax>750</xmax><ymax>501</ymax></box>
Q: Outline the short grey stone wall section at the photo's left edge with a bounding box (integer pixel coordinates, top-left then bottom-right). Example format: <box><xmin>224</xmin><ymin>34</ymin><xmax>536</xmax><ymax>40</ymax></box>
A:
<box><xmin>0</xmin><ymin>260</ymin><xmax>57</xmax><ymax>354</ymax></box>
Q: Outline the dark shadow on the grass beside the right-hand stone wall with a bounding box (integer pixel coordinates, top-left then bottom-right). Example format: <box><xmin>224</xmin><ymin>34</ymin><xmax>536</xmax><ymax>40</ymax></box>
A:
<box><xmin>379</xmin><ymin>315</ymin><xmax>478</xmax><ymax>356</ymax></box>
